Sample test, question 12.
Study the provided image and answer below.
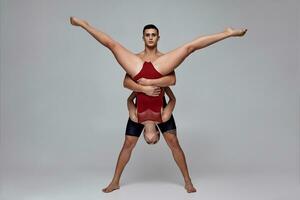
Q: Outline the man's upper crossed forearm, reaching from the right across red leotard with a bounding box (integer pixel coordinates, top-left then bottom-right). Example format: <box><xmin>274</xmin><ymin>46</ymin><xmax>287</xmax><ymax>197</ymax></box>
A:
<box><xmin>137</xmin><ymin>71</ymin><xmax>176</xmax><ymax>87</ymax></box>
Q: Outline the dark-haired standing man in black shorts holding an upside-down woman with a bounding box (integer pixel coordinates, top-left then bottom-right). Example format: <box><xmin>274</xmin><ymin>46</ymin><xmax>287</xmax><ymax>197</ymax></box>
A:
<box><xmin>102</xmin><ymin>24</ymin><xmax>196</xmax><ymax>193</ymax></box>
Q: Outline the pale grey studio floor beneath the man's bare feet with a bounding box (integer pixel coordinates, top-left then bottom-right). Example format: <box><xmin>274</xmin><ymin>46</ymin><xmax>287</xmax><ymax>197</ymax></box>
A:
<box><xmin>0</xmin><ymin>170</ymin><xmax>300</xmax><ymax>200</ymax></box>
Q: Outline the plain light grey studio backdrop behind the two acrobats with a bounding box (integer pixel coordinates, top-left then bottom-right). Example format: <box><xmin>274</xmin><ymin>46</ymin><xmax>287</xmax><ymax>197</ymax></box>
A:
<box><xmin>0</xmin><ymin>0</ymin><xmax>300</xmax><ymax>191</ymax></box>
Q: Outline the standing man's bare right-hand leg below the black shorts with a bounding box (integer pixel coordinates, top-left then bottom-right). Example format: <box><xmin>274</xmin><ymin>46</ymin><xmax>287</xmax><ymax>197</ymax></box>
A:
<box><xmin>163</xmin><ymin>132</ymin><xmax>196</xmax><ymax>193</ymax></box>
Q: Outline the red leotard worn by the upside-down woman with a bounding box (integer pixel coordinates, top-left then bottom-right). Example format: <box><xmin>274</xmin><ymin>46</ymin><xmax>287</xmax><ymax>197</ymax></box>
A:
<box><xmin>133</xmin><ymin>61</ymin><xmax>163</xmax><ymax>123</ymax></box>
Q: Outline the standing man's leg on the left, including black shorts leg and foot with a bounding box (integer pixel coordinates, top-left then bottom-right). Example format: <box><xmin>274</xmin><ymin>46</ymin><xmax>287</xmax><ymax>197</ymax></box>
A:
<box><xmin>102</xmin><ymin>118</ymin><xmax>144</xmax><ymax>193</ymax></box>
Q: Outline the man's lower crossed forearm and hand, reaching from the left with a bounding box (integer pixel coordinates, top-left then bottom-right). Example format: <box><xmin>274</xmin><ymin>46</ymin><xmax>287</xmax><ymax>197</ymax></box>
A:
<box><xmin>123</xmin><ymin>74</ymin><xmax>160</xmax><ymax>96</ymax></box>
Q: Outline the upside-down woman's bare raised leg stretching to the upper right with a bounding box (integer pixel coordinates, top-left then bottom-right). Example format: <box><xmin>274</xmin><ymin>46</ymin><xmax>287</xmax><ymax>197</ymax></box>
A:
<box><xmin>153</xmin><ymin>28</ymin><xmax>247</xmax><ymax>75</ymax></box>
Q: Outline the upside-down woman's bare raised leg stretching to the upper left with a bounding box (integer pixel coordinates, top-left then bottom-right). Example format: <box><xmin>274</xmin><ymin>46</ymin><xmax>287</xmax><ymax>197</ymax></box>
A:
<box><xmin>70</xmin><ymin>17</ymin><xmax>143</xmax><ymax>77</ymax></box>
